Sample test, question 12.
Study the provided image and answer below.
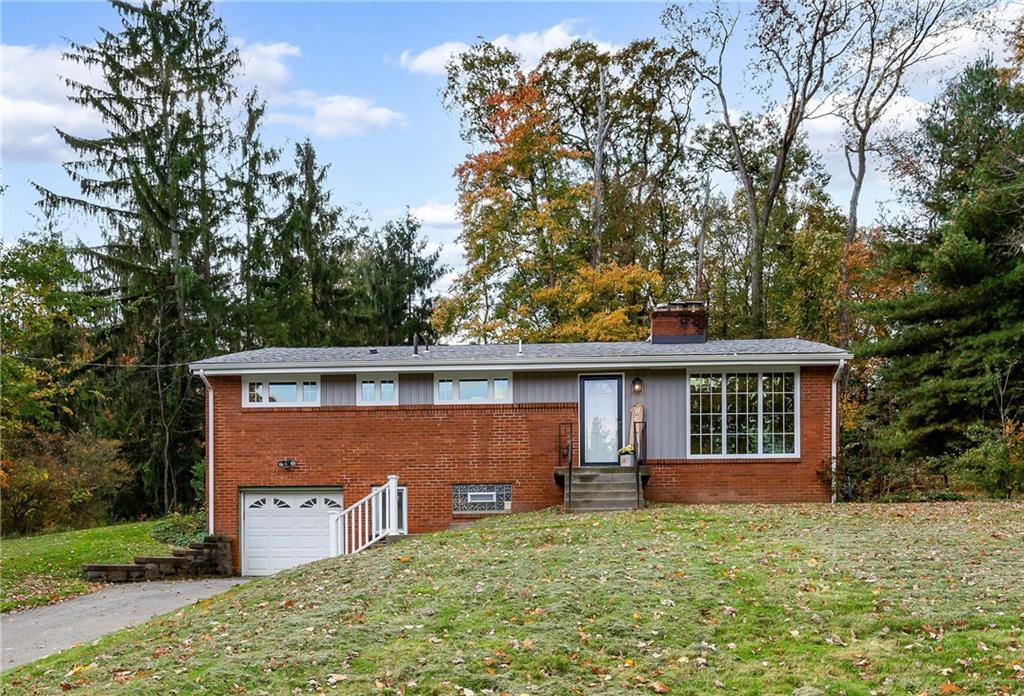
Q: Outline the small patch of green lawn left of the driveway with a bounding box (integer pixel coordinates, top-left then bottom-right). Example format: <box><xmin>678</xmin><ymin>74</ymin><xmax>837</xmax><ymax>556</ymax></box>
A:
<box><xmin>0</xmin><ymin>522</ymin><xmax>171</xmax><ymax>612</ymax></box>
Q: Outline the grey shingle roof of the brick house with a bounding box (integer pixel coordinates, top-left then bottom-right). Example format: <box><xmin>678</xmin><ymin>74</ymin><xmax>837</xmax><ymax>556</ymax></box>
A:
<box><xmin>193</xmin><ymin>339</ymin><xmax>849</xmax><ymax>368</ymax></box>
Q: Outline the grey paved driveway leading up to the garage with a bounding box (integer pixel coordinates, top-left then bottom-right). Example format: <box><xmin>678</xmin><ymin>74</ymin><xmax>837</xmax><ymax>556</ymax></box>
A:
<box><xmin>0</xmin><ymin>577</ymin><xmax>245</xmax><ymax>669</ymax></box>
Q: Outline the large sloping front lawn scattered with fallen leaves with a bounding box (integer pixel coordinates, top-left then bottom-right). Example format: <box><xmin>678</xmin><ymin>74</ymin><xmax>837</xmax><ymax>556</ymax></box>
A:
<box><xmin>0</xmin><ymin>503</ymin><xmax>1024</xmax><ymax>695</ymax></box>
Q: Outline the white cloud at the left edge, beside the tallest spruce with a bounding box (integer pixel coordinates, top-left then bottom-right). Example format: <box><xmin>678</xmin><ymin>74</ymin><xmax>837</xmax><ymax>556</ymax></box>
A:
<box><xmin>0</xmin><ymin>44</ymin><xmax>102</xmax><ymax>163</ymax></box>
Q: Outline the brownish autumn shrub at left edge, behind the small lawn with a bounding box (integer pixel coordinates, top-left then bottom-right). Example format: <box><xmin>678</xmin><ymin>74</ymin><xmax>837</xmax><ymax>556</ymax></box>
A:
<box><xmin>0</xmin><ymin>428</ymin><xmax>131</xmax><ymax>534</ymax></box>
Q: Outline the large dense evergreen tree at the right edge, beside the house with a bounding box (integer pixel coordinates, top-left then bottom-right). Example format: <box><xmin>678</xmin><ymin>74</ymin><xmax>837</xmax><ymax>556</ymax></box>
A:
<box><xmin>853</xmin><ymin>61</ymin><xmax>1024</xmax><ymax>479</ymax></box>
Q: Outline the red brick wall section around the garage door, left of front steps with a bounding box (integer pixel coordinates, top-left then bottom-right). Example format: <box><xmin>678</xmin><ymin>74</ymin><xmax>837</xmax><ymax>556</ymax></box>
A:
<box><xmin>210</xmin><ymin>378</ymin><xmax>577</xmax><ymax>569</ymax></box>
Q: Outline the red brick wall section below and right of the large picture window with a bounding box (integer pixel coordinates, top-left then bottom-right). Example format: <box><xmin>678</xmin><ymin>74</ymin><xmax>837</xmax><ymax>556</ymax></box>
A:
<box><xmin>644</xmin><ymin>367</ymin><xmax>836</xmax><ymax>503</ymax></box>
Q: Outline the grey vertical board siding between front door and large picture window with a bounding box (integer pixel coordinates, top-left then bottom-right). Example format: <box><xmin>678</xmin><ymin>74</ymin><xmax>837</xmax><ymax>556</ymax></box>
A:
<box><xmin>624</xmin><ymin>369</ymin><xmax>687</xmax><ymax>460</ymax></box>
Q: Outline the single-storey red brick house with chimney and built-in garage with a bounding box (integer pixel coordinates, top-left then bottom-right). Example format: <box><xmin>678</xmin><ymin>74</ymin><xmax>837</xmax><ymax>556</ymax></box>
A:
<box><xmin>190</xmin><ymin>302</ymin><xmax>852</xmax><ymax>574</ymax></box>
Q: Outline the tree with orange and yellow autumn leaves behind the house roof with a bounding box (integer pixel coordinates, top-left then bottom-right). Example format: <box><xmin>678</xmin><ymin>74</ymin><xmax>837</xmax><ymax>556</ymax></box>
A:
<box><xmin>436</xmin><ymin>73</ymin><xmax>662</xmax><ymax>342</ymax></box>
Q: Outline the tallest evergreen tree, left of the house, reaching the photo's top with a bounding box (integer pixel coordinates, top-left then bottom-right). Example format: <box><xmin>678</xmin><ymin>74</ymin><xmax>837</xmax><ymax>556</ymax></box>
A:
<box><xmin>38</xmin><ymin>0</ymin><xmax>239</xmax><ymax>510</ymax></box>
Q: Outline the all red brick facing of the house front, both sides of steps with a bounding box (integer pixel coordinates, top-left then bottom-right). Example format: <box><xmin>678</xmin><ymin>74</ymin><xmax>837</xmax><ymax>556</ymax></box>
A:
<box><xmin>203</xmin><ymin>367</ymin><xmax>834</xmax><ymax>569</ymax></box>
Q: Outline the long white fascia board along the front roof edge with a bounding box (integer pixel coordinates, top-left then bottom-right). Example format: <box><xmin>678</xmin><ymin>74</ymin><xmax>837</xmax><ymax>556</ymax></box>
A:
<box><xmin>189</xmin><ymin>353</ymin><xmax>853</xmax><ymax>376</ymax></box>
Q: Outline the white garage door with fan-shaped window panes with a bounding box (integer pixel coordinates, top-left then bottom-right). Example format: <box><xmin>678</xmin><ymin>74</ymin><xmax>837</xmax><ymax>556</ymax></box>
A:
<box><xmin>242</xmin><ymin>488</ymin><xmax>344</xmax><ymax>575</ymax></box>
